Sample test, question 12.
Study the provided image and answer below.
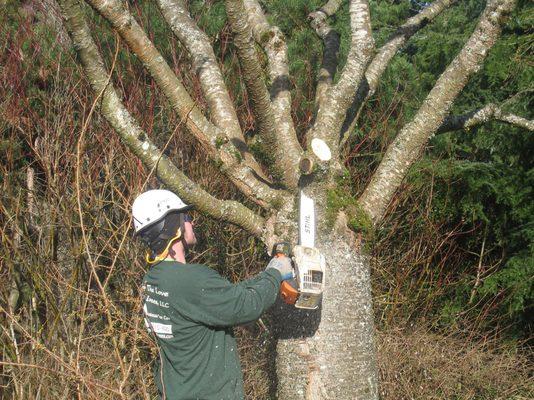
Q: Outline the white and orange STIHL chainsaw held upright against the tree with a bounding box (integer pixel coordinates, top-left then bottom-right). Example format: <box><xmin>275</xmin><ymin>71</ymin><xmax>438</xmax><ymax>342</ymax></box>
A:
<box><xmin>272</xmin><ymin>191</ymin><xmax>326</xmax><ymax>310</ymax></box>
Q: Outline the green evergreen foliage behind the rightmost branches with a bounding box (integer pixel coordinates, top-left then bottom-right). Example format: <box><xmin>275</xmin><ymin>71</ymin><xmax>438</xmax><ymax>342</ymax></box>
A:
<box><xmin>363</xmin><ymin>1</ymin><xmax>534</xmax><ymax>334</ymax></box>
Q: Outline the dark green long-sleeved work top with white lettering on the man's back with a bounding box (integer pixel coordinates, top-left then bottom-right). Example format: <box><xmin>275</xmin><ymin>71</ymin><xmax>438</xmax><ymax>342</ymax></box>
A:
<box><xmin>143</xmin><ymin>261</ymin><xmax>281</xmax><ymax>400</ymax></box>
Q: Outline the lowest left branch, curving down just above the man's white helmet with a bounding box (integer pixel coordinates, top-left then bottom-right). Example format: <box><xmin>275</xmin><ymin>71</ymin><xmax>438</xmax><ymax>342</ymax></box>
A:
<box><xmin>60</xmin><ymin>0</ymin><xmax>264</xmax><ymax>236</ymax></box>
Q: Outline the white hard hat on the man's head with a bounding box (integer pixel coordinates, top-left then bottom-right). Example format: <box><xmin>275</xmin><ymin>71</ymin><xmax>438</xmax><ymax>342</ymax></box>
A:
<box><xmin>132</xmin><ymin>189</ymin><xmax>192</xmax><ymax>234</ymax></box>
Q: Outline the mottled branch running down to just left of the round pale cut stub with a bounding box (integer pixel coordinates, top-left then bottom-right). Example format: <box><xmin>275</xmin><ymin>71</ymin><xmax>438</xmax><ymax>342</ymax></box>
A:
<box><xmin>243</xmin><ymin>0</ymin><xmax>302</xmax><ymax>182</ymax></box>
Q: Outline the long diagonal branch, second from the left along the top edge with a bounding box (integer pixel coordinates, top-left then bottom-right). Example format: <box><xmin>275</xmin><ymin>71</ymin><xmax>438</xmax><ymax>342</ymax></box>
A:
<box><xmin>86</xmin><ymin>0</ymin><xmax>281</xmax><ymax>208</ymax></box>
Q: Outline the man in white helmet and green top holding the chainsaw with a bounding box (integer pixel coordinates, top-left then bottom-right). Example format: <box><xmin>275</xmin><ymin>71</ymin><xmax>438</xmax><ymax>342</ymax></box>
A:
<box><xmin>132</xmin><ymin>190</ymin><xmax>292</xmax><ymax>400</ymax></box>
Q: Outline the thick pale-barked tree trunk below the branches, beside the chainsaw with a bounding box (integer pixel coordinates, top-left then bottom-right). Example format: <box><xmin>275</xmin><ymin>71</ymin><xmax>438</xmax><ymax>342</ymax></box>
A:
<box><xmin>273</xmin><ymin>234</ymin><xmax>378</xmax><ymax>400</ymax></box>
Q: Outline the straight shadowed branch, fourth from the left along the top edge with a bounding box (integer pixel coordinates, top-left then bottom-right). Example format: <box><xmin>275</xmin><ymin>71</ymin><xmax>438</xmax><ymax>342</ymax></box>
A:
<box><xmin>226</xmin><ymin>0</ymin><xmax>302</xmax><ymax>188</ymax></box>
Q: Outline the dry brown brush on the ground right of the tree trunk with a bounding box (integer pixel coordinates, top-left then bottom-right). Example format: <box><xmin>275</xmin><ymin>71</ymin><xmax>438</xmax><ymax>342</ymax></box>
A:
<box><xmin>378</xmin><ymin>329</ymin><xmax>534</xmax><ymax>400</ymax></box>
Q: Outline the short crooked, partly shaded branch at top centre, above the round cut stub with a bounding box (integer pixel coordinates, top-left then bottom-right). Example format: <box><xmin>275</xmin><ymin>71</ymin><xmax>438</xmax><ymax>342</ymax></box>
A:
<box><xmin>309</xmin><ymin>0</ymin><xmax>342</xmax><ymax>107</ymax></box>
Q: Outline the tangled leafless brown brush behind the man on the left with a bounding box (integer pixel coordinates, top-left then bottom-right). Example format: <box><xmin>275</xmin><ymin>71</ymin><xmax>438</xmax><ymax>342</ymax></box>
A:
<box><xmin>0</xmin><ymin>7</ymin><xmax>265</xmax><ymax>399</ymax></box>
